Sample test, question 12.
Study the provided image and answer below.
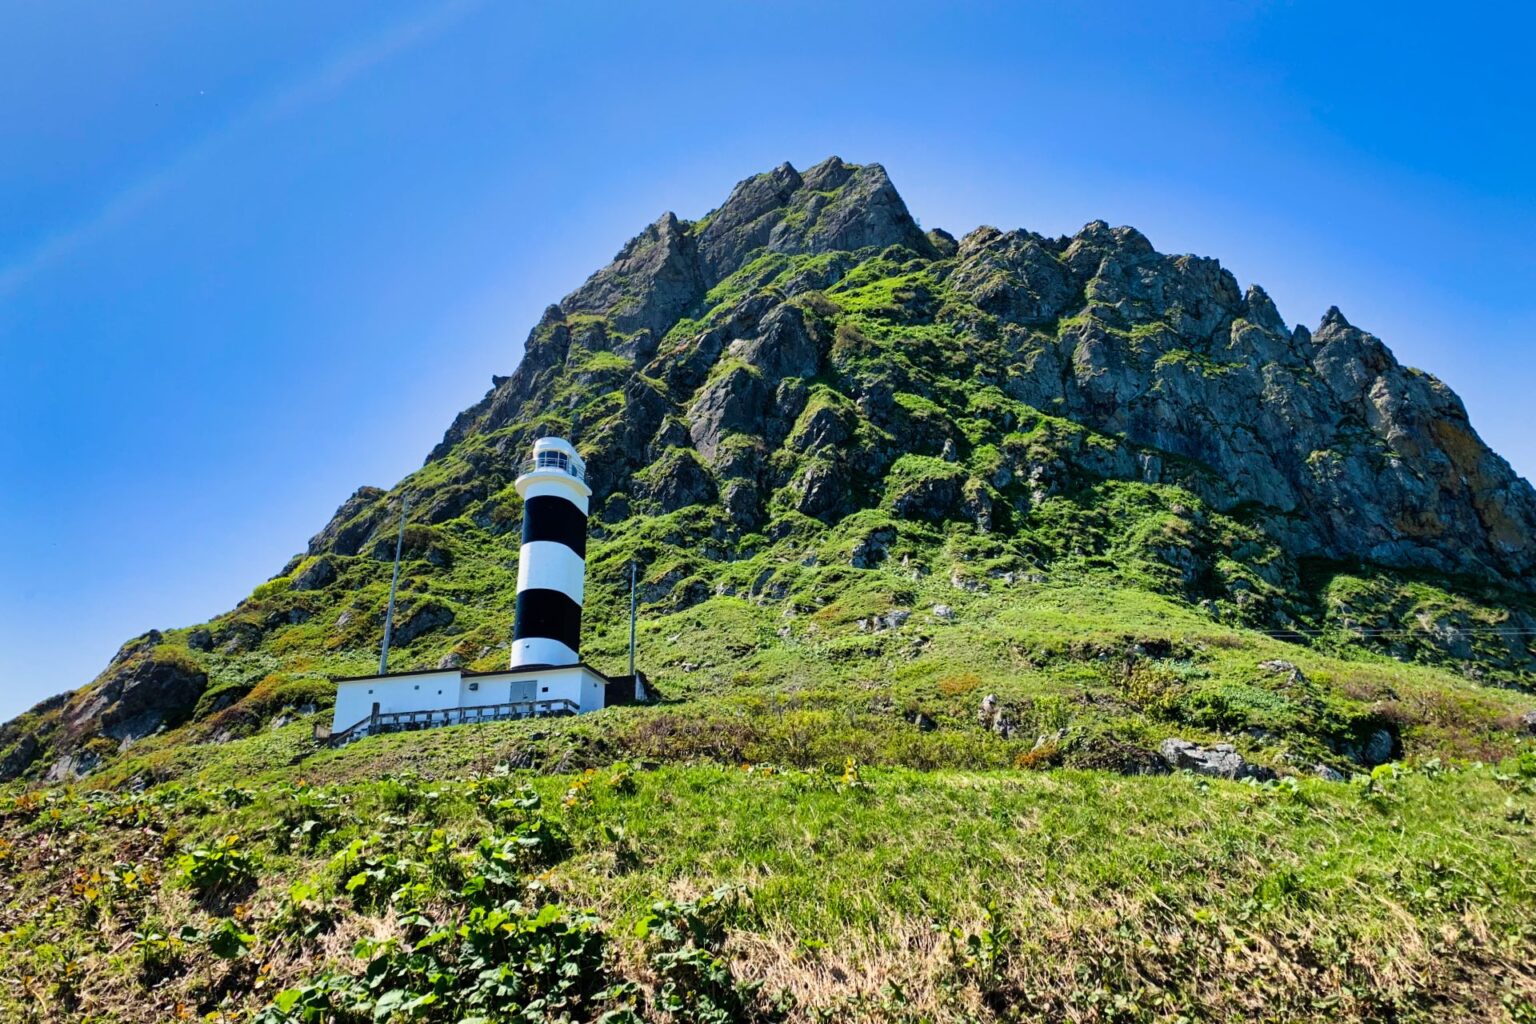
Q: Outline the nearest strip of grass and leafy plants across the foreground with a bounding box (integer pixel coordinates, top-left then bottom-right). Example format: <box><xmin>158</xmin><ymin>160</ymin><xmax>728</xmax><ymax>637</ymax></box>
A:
<box><xmin>0</xmin><ymin>758</ymin><xmax>1536</xmax><ymax>1021</ymax></box>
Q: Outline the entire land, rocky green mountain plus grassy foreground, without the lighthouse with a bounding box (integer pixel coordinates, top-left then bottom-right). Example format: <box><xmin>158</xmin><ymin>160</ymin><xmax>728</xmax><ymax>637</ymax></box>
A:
<box><xmin>0</xmin><ymin>158</ymin><xmax>1536</xmax><ymax>1024</ymax></box>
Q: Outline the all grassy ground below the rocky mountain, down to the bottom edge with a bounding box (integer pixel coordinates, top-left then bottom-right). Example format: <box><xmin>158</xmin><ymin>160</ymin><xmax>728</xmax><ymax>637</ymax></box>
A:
<box><xmin>0</xmin><ymin>574</ymin><xmax>1536</xmax><ymax>1021</ymax></box>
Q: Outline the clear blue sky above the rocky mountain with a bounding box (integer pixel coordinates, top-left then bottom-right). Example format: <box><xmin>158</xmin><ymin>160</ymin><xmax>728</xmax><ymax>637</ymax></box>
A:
<box><xmin>0</xmin><ymin>0</ymin><xmax>1536</xmax><ymax>718</ymax></box>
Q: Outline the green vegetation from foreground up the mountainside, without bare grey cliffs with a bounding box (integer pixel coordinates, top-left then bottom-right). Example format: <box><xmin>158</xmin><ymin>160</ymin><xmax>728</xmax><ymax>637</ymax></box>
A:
<box><xmin>0</xmin><ymin>191</ymin><xmax>1536</xmax><ymax>1024</ymax></box>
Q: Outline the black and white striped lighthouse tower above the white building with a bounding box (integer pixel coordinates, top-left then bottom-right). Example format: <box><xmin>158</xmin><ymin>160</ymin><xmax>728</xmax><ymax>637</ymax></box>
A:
<box><xmin>511</xmin><ymin>438</ymin><xmax>591</xmax><ymax>668</ymax></box>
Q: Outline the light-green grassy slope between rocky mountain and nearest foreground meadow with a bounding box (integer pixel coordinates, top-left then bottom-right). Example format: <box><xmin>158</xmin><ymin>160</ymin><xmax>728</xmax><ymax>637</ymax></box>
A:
<box><xmin>81</xmin><ymin>570</ymin><xmax>1530</xmax><ymax>786</ymax></box>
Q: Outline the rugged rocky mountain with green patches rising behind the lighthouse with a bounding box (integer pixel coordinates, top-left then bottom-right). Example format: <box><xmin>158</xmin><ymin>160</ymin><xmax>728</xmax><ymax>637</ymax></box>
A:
<box><xmin>9</xmin><ymin>158</ymin><xmax>1536</xmax><ymax>778</ymax></box>
